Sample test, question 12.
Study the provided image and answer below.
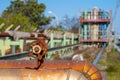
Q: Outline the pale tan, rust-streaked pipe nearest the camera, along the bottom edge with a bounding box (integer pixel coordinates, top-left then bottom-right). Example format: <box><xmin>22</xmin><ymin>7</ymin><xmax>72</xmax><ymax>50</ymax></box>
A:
<box><xmin>0</xmin><ymin>69</ymin><xmax>87</xmax><ymax>80</ymax></box>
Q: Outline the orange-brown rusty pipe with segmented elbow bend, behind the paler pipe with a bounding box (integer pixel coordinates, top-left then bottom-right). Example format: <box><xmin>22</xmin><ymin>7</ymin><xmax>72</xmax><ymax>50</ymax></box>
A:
<box><xmin>0</xmin><ymin>60</ymin><xmax>102</xmax><ymax>80</ymax></box>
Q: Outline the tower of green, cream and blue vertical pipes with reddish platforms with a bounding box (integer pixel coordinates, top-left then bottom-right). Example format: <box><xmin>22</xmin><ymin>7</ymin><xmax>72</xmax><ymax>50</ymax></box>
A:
<box><xmin>79</xmin><ymin>7</ymin><xmax>111</xmax><ymax>47</ymax></box>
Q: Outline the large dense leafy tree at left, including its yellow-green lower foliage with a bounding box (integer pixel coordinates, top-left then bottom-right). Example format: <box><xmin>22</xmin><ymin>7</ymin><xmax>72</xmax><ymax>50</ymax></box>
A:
<box><xmin>2</xmin><ymin>0</ymin><xmax>51</xmax><ymax>31</ymax></box>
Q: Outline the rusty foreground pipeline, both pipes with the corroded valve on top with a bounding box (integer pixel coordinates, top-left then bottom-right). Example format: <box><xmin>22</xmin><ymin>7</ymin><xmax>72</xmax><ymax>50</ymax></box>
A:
<box><xmin>0</xmin><ymin>35</ymin><xmax>102</xmax><ymax>80</ymax></box>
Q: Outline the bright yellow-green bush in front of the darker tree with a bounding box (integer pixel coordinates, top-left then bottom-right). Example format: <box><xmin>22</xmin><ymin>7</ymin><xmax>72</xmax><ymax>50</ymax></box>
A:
<box><xmin>0</xmin><ymin>13</ymin><xmax>35</xmax><ymax>32</ymax></box>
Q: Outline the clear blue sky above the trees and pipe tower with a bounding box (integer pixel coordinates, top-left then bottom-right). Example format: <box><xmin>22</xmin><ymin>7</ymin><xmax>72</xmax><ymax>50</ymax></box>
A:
<box><xmin>0</xmin><ymin>0</ymin><xmax>120</xmax><ymax>33</ymax></box>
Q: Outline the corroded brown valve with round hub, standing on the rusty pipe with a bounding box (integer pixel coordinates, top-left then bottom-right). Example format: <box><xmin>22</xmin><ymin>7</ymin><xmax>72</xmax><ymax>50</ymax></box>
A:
<box><xmin>28</xmin><ymin>37</ymin><xmax>47</xmax><ymax>69</ymax></box>
